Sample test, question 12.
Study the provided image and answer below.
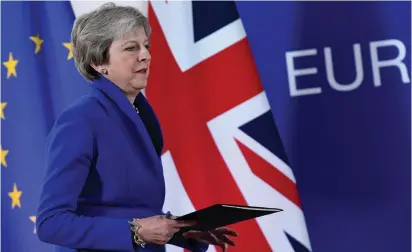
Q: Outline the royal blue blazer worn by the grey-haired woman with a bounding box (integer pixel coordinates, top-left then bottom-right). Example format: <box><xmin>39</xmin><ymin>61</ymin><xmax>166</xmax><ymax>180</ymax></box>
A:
<box><xmin>36</xmin><ymin>77</ymin><xmax>208</xmax><ymax>252</ymax></box>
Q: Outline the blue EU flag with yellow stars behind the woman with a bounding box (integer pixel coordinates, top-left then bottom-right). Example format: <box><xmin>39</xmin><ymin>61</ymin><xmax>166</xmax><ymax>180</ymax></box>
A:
<box><xmin>0</xmin><ymin>1</ymin><xmax>88</xmax><ymax>252</ymax></box>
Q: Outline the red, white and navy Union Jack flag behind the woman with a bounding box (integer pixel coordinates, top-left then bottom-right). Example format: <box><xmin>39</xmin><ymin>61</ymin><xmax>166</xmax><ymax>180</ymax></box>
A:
<box><xmin>146</xmin><ymin>1</ymin><xmax>311</xmax><ymax>252</ymax></box>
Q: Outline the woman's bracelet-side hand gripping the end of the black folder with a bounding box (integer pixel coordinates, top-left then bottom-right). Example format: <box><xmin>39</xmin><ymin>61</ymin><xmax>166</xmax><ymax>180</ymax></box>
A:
<box><xmin>137</xmin><ymin>215</ymin><xmax>196</xmax><ymax>245</ymax></box>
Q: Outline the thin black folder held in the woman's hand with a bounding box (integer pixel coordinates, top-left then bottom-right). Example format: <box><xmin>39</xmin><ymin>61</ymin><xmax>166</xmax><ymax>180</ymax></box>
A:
<box><xmin>176</xmin><ymin>204</ymin><xmax>283</xmax><ymax>232</ymax></box>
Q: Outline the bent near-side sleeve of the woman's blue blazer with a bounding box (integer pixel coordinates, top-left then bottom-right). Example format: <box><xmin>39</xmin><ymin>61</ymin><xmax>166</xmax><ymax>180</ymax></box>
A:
<box><xmin>36</xmin><ymin>111</ymin><xmax>134</xmax><ymax>251</ymax></box>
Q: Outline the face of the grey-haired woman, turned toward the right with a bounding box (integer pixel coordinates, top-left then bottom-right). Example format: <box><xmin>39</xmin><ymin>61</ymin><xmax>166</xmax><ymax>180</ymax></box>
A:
<box><xmin>103</xmin><ymin>28</ymin><xmax>151</xmax><ymax>94</ymax></box>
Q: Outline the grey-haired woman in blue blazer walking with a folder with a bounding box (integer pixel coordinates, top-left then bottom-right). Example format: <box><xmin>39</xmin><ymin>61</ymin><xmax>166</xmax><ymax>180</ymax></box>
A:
<box><xmin>37</xmin><ymin>4</ymin><xmax>237</xmax><ymax>252</ymax></box>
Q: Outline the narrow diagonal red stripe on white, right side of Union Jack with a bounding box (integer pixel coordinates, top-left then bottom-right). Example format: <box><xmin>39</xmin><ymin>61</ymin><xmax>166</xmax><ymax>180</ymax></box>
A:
<box><xmin>236</xmin><ymin>141</ymin><xmax>301</xmax><ymax>207</ymax></box>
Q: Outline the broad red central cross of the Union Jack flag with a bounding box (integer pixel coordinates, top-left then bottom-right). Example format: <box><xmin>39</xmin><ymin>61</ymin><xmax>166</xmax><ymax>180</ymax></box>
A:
<box><xmin>146</xmin><ymin>4</ymin><xmax>271</xmax><ymax>251</ymax></box>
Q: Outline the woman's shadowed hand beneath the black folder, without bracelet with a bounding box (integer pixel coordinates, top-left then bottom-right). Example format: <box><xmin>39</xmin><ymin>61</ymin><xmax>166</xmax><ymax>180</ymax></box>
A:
<box><xmin>183</xmin><ymin>227</ymin><xmax>239</xmax><ymax>252</ymax></box>
